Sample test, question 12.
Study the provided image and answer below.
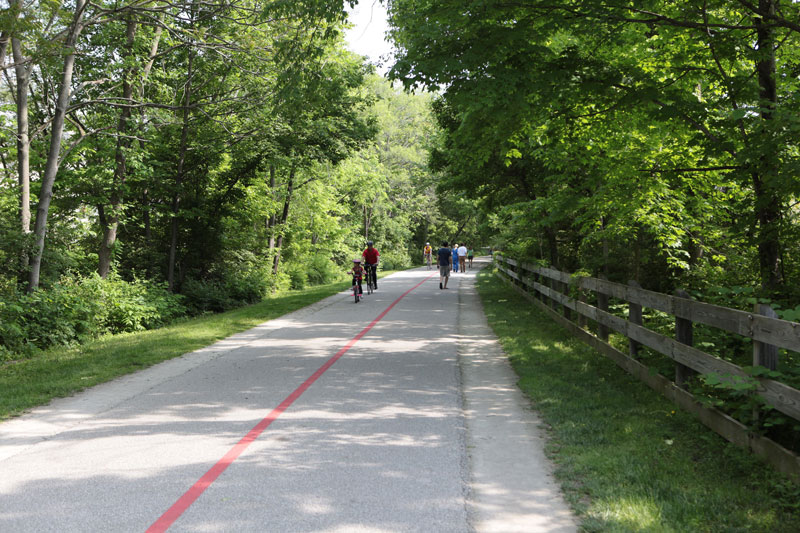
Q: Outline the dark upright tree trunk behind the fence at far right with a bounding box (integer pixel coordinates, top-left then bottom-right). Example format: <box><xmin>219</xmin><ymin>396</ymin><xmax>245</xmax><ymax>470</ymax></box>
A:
<box><xmin>753</xmin><ymin>0</ymin><xmax>785</xmax><ymax>292</ymax></box>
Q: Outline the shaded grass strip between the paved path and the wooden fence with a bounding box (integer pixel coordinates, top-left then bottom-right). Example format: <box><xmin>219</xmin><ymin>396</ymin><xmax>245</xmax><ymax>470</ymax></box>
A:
<box><xmin>478</xmin><ymin>269</ymin><xmax>800</xmax><ymax>533</ymax></box>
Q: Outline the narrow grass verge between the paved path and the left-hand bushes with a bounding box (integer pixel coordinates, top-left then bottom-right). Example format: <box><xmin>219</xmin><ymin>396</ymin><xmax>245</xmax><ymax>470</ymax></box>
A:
<box><xmin>0</xmin><ymin>278</ymin><xmax>356</xmax><ymax>420</ymax></box>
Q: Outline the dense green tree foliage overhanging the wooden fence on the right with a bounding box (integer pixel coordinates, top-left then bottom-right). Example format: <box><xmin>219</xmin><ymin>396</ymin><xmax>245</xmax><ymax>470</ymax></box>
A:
<box><xmin>389</xmin><ymin>0</ymin><xmax>800</xmax><ymax>300</ymax></box>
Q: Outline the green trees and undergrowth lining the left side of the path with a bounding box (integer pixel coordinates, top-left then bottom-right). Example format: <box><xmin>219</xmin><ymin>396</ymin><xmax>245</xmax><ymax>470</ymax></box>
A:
<box><xmin>0</xmin><ymin>0</ymin><xmax>468</xmax><ymax>370</ymax></box>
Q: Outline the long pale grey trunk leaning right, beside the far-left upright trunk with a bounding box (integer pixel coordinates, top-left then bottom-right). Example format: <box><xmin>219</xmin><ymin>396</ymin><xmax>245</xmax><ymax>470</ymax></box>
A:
<box><xmin>28</xmin><ymin>0</ymin><xmax>86</xmax><ymax>292</ymax></box>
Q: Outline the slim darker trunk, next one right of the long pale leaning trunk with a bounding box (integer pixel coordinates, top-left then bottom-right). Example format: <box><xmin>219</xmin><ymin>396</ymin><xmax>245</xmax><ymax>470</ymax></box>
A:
<box><xmin>97</xmin><ymin>16</ymin><xmax>136</xmax><ymax>278</ymax></box>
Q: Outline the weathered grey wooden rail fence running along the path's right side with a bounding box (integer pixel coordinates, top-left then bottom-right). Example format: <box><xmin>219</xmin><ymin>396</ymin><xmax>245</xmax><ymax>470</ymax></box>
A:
<box><xmin>494</xmin><ymin>254</ymin><xmax>800</xmax><ymax>479</ymax></box>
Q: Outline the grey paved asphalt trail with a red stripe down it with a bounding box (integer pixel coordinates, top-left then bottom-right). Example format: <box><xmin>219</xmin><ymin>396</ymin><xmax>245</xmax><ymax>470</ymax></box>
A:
<box><xmin>0</xmin><ymin>256</ymin><xmax>575</xmax><ymax>533</ymax></box>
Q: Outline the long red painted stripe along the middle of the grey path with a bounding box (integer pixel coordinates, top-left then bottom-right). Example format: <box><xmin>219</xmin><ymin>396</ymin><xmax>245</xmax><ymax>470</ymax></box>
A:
<box><xmin>147</xmin><ymin>274</ymin><xmax>434</xmax><ymax>533</ymax></box>
